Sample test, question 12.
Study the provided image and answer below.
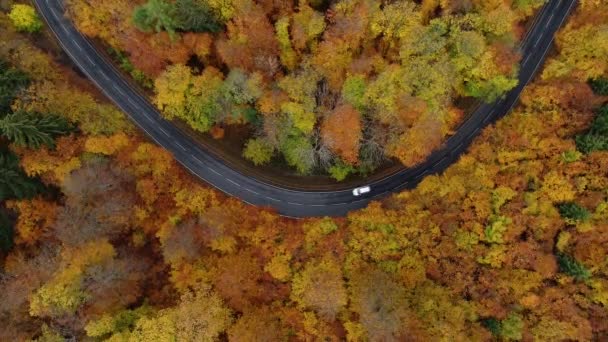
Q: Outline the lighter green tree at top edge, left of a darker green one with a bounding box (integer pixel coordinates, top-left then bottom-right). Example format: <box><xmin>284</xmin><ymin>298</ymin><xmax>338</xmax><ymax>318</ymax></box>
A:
<box><xmin>133</xmin><ymin>0</ymin><xmax>180</xmax><ymax>37</ymax></box>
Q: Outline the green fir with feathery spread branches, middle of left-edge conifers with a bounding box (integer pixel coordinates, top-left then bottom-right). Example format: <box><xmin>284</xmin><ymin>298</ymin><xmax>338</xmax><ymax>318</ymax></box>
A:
<box><xmin>0</xmin><ymin>111</ymin><xmax>73</xmax><ymax>149</ymax></box>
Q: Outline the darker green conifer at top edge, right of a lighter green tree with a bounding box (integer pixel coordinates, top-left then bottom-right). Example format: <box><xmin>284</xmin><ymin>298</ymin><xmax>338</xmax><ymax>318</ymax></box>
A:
<box><xmin>175</xmin><ymin>0</ymin><xmax>223</xmax><ymax>33</ymax></box>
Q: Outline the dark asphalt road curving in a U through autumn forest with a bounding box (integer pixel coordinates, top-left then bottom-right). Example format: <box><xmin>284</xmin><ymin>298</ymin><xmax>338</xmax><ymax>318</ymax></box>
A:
<box><xmin>34</xmin><ymin>0</ymin><xmax>577</xmax><ymax>217</ymax></box>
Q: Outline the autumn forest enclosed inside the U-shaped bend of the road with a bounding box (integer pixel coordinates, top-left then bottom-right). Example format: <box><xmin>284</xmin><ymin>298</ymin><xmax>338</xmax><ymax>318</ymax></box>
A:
<box><xmin>68</xmin><ymin>0</ymin><xmax>544</xmax><ymax>180</ymax></box>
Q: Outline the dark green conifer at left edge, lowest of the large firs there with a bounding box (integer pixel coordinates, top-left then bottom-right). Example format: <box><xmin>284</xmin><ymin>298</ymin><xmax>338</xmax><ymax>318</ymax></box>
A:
<box><xmin>0</xmin><ymin>151</ymin><xmax>44</xmax><ymax>201</ymax></box>
